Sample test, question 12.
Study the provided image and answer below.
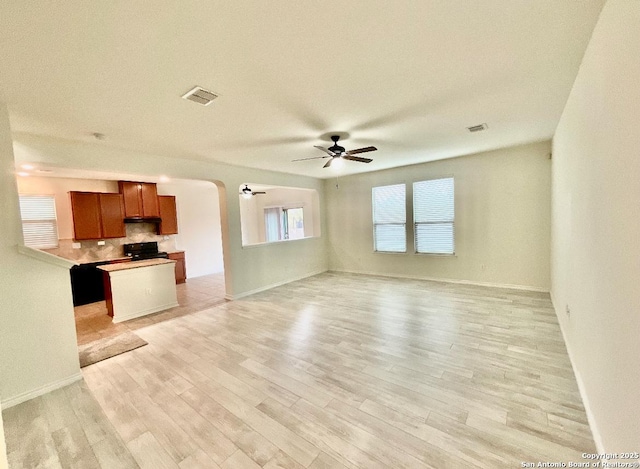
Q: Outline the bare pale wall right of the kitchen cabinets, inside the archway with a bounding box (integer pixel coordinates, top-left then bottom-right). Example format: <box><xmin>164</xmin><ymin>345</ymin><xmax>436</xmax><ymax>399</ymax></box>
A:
<box><xmin>158</xmin><ymin>181</ymin><xmax>224</xmax><ymax>278</ymax></box>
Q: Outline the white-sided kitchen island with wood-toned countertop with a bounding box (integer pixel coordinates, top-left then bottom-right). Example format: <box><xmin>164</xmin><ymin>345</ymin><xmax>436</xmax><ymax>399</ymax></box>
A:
<box><xmin>98</xmin><ymin>259</ymin><xmax>178</xmax><ymax>322</ymax></box>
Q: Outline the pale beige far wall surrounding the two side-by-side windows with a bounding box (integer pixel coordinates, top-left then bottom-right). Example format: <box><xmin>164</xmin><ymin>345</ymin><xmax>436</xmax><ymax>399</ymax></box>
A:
<box><xmin>325</xmin><ymin>142</ymin><xmax>551</xmax><ymax>291</ymax></box>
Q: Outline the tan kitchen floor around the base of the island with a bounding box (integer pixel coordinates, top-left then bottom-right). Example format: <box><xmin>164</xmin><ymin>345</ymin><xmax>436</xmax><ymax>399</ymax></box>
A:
<box><xmin>74</xmin><ymin>273</ymin><xmax>225</xmax><ymax>345</ymax></box>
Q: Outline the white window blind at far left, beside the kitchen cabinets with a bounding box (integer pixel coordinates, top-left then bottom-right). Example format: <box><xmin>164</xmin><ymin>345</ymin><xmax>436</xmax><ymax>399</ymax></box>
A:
<box><xmin>20</xmin><ymin>195</ymin><xmax>58</xmax><ymax>249</ymax></box>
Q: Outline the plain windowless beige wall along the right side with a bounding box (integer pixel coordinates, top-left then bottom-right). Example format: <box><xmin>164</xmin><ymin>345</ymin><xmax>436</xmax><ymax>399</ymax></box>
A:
<box><xmin>552</xmin><ymin>0</ymin><xmax>640</xmax><ymax>452</ymax></box>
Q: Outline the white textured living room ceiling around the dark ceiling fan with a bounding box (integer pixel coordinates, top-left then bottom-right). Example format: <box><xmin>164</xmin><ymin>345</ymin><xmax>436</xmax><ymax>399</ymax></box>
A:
<box><xmin>0</xmin><ymin>0</ymin><xmax>604</xmax><ymax>177</ymax></box>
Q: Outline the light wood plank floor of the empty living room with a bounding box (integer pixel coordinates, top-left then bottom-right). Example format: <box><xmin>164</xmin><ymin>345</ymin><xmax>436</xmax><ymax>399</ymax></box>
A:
<box><xmin>3</xmin><ymin>273</ymin><xmax>596</xmax><ymax>469</ymax></box>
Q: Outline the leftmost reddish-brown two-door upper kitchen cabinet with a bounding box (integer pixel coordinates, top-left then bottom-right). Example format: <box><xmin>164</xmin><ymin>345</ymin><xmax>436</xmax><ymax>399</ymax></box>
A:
<box><xmin>69</xmin><ymin>192</ymin><xmax>126</xmax><ymax>240</ymax></box>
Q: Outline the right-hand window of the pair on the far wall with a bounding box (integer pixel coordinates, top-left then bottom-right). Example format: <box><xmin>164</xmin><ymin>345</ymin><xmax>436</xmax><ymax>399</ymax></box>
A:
<box><xmin>413</xmin><ymin>178</ymin><xmax>454</xmax><ymax>254</ymax></box>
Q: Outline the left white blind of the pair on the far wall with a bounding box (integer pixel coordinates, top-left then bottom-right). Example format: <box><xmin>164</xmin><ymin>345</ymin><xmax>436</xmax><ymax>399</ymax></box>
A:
<box><xmin>372</xmin><ymin>184</ymin><xmax>407</xmax><ymax>252</ymax></box>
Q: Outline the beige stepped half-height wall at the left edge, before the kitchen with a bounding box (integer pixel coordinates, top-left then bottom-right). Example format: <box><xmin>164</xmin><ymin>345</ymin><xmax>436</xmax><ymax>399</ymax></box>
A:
<box><xmin>0</xmin><ymin>105</ymin><xmax>80</xmax><ymax>407</ymax></box>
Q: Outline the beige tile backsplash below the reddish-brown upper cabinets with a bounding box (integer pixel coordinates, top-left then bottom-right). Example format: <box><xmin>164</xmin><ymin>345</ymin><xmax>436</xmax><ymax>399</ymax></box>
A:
<box><xmin>44</xmin><ymin>223</ymin><xmax>176</xmax><ymax>263</ymax></box>
